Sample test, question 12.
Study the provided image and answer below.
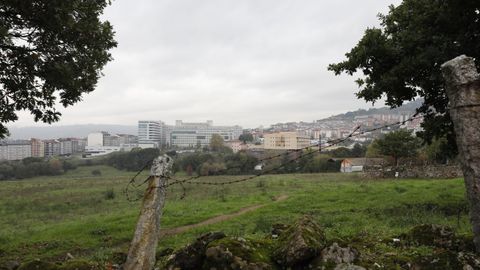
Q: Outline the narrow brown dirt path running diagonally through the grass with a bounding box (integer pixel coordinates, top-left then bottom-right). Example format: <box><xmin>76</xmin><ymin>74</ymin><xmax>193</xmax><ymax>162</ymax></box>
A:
<box><xmin>160</xmin><ymin>195</ymin><xmax>288</xmax><ymax>237</ymax></box>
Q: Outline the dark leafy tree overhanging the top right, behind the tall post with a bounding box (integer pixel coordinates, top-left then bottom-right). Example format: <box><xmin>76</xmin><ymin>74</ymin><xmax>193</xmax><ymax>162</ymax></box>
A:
<box><xmin>329</xmin><ymin>0</ymin><xmax>480</xmax><ymax>156</ymax></box>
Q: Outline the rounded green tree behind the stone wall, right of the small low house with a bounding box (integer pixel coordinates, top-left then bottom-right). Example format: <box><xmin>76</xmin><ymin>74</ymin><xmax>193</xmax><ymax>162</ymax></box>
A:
<box><xmin>375</xmin><ymin>129</ymin><xmax>421</xmax><ymax>166</ymax></box>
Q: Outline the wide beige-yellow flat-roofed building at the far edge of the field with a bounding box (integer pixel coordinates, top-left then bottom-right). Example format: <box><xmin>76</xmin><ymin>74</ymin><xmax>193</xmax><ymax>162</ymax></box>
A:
<box><xmin>263</xmin><ymin>132</ymin><xmax>310</xmax><ymax>150</ymax></box>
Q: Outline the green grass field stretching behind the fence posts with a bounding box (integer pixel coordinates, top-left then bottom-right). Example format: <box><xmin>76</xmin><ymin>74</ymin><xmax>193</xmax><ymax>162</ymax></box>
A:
<box><xmin>0</xmin><ymin>166</ymin><xmax>470</xmax><ymax>263</ymax></box>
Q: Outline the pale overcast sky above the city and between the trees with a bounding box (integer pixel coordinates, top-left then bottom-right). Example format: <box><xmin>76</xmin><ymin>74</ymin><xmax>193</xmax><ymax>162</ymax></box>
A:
<box><xmin>11</xmin><ymin>0</ymin><xmax>400</xmax><ymax>127</ymax></box>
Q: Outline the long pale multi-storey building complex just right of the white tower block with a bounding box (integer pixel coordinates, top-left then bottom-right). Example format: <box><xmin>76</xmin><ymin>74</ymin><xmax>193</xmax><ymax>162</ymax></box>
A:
<box><xmin>169</xmin><ymin>120</ymin><xmax>243</xmax><ymax>147</ymax></box>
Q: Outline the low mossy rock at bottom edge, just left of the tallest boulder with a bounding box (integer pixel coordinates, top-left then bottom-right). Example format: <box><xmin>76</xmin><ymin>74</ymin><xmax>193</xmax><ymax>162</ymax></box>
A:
<box><xmin>203</xmin><ymin>237</ymin><xmax>274</xmax><ymax>270</ymax></box>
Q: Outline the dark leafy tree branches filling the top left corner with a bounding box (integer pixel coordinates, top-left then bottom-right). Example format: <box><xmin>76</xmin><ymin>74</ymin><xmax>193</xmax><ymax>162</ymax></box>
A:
<box><xmin>0</xmin><ymin>0</ymin><xmax>116</xmax><ymax>138</ymax></box>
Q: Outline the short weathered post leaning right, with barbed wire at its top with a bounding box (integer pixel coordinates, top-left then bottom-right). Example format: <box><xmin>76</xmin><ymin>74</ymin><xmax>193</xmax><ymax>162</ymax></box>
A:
<box><xmin>123</xmin><ymin>155</ymin><xmax>173</xmax><ymax>270</ymax></box>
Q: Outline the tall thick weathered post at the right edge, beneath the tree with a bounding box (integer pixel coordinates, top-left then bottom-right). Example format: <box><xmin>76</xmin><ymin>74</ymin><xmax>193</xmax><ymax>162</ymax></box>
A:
<box><xmin>442</xmin><ymin>55</ymin><xmax>480</xmax><ymax>252</ymax></box>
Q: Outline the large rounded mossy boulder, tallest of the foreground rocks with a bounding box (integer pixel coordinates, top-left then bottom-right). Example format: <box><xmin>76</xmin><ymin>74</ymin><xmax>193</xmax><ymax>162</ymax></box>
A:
<box><xmin>273</xmin><ymin>216</ymin><xmax>327</xmax><ymax>268</ymax></box>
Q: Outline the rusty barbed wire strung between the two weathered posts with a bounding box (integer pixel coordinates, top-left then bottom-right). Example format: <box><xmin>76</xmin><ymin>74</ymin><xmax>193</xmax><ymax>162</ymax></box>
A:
<box><xmin>125</xmin><ymin>111</ymin><xmax>423</xmax><ymax>201</ymax></box>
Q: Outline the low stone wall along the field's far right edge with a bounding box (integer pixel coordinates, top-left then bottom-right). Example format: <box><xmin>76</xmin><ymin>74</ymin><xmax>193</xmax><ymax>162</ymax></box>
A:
<box><xmin>364</xmin><ymin>165</ymin><xmax>463</xmax><ymax>178</ymax></box>
